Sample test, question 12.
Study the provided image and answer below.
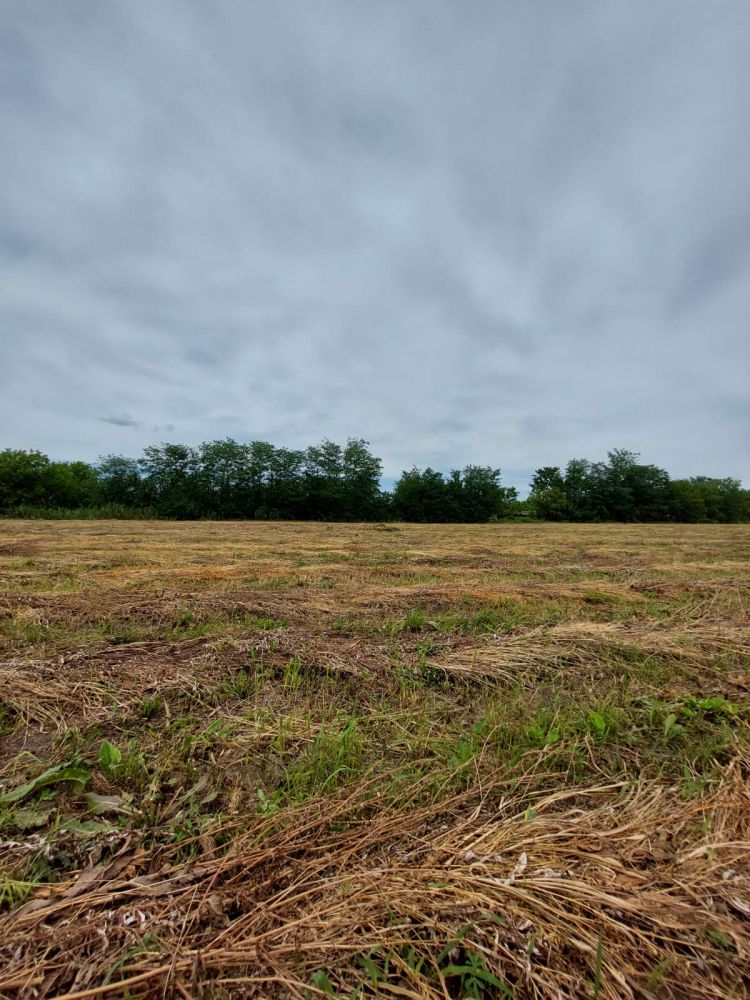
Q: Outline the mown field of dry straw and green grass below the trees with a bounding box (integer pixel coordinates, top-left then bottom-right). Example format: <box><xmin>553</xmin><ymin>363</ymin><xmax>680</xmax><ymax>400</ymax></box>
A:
<box><xmin>0</xmin><ymin>521</ymin><xmax>750</xmax><ymax>1000</ymax></box>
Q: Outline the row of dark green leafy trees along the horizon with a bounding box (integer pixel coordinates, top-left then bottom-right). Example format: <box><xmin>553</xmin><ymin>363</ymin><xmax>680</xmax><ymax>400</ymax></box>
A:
<box><xmin>0</xmin><ymin>438</ymin><xmax>750</xmax><ymax>523</ymax></box>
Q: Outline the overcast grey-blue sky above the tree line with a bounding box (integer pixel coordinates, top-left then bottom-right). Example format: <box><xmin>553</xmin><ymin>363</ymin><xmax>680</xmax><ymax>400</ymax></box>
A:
<box><xmin>0</xmin><ymin>0</ymin><xmax>750</xmax><ymax>488</ymax></box>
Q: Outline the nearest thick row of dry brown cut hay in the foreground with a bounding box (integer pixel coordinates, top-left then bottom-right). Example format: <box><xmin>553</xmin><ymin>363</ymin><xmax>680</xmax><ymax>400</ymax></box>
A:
<box><xmin>0</xmin><ymin>770</ymin><xmax>750</xmax><ymax>1000</ymax></box>
